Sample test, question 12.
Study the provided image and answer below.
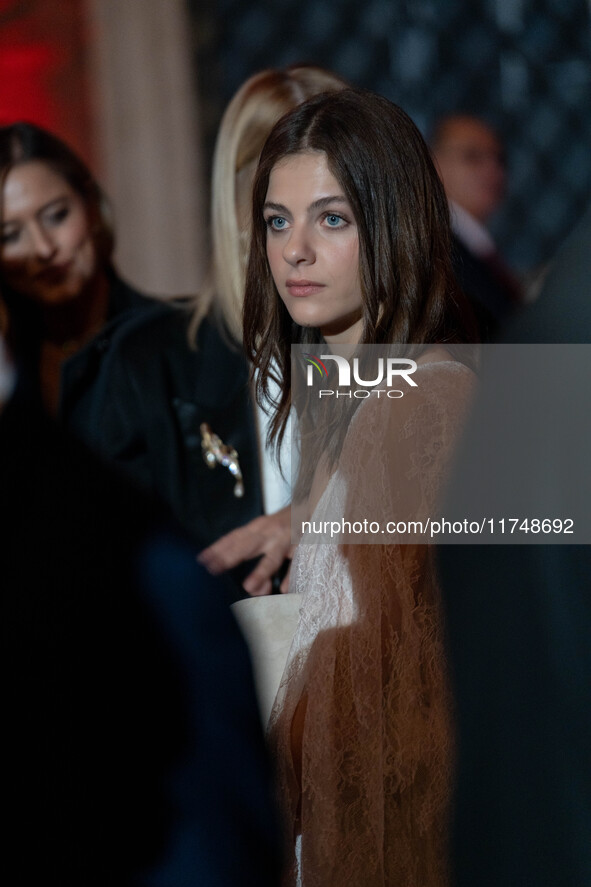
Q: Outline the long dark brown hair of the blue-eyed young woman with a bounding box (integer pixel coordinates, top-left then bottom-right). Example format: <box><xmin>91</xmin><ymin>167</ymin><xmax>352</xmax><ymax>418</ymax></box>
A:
<box><xmin>244</xmin><ymin>89</ymin><xmax>475</xmax><ymax>458</ymax></box>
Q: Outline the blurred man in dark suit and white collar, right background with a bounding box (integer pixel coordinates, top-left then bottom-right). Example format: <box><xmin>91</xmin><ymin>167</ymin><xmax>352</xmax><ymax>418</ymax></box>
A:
<box><xmin>430</xmin><ymin>114</ymin><xmax>522</xmax><ymax>341</ymax></box>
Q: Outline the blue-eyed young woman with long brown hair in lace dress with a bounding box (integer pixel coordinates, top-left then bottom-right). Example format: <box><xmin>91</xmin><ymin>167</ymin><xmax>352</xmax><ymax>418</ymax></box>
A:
<box><xmin>244</xmin><ymin>90</ymin><xmax>473</xmax><ymax>887</ymax></box>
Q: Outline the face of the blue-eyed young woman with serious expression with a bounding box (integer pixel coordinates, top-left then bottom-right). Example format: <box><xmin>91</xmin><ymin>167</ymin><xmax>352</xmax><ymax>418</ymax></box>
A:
<box><xmin>263</xmin><ymin>151</ymin><xmax>362</xmax><ymax>344</ymax></box>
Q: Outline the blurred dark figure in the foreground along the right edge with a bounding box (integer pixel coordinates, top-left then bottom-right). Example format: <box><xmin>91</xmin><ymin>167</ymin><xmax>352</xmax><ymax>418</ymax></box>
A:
<box><xmin>439</xmin><ymin>203</ymin><xmax>591</xmax><ymax>887</ymax></box>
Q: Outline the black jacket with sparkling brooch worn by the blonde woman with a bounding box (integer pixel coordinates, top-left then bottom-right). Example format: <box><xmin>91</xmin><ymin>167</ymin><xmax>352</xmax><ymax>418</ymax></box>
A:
<box><xmin>87</xmin><ymin>305</ymin><xmax>262</xmax><ymax>564</ymax></box>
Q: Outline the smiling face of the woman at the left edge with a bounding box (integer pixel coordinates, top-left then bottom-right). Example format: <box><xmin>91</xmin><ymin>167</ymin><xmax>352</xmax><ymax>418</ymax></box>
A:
<box><xmin>0</xmin><ymin>160</ymin><xmax>97</xmax><ymax>306</ymax></box>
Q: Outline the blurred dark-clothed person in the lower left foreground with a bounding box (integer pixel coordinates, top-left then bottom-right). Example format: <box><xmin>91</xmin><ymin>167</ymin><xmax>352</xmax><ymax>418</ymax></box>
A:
<box><xmin>0</xmin><ymin>334</ymin><xmax>280</xmax><ymax>887</ymax></box>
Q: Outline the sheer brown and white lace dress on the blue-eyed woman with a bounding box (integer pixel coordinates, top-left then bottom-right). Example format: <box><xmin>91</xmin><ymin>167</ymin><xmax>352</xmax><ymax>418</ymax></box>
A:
<box><xmin>269</xmin><ymin>362</ymin><xmax>473</xmax><ymax>887</ymax></box>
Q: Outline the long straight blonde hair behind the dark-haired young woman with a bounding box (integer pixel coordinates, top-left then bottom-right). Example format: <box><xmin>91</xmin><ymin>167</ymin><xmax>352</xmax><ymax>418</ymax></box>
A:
<box><xmin>189</xmin><ymin>65</ymin><xmax>348</xmax><ymax>341</ymax></box>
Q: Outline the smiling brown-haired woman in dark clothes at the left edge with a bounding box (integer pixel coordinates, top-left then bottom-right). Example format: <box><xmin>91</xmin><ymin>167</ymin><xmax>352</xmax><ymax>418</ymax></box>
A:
<box><xmin>0</xmin><ymin>123</ymin><xmax>162</xmax><ymax>424</ymax></box>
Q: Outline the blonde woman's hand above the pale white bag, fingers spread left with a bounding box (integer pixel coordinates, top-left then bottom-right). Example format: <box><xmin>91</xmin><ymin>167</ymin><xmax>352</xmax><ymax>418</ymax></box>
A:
<box><xmin>199</xmin><ymin>505</ymin><xmax>293</xmax><ymax>596</ymax></box>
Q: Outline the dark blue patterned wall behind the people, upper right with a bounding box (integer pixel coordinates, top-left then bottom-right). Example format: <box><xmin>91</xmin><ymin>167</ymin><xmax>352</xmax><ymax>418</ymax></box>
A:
<box><xmin>187</xmin><ymin>0</ymin><xmax>591</xmax><ymax>272</ymax></box>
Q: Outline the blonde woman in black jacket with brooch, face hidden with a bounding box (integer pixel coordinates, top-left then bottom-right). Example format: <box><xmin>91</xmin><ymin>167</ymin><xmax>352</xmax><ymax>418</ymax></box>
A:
<box><xmin>95</xmin><ymin>65</ymin><xmax>346</xmax><ymax>595</ymax></box>
